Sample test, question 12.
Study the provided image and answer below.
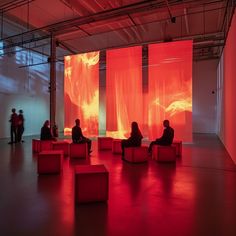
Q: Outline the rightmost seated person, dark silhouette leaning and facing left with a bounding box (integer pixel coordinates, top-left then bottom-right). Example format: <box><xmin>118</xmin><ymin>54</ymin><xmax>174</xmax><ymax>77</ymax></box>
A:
<box><xmin>148</xmin><ymin>120</ymin><xmax>174</xmax><ymax>153</ymax></box>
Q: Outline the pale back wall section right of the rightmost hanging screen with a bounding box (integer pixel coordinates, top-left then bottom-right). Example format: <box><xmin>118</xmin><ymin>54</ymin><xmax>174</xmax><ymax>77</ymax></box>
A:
<box><xmin>192</xmin><ymin>60</ymin><xmax>218</xmax><ymax>133</ymax></box>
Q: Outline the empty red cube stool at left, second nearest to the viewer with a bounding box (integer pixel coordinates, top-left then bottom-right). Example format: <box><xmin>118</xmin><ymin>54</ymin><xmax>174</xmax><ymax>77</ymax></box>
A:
<box><xmin>38</xmin><ymin>150</ymin><xmax>63</xmax><ymax>174</ymax></box>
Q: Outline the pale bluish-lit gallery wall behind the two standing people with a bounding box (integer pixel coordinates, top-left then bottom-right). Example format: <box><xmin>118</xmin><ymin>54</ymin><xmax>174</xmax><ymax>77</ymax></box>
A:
<box><xmin>0</xmin><ymin>46</ymin><xmax>64</xmax><ymax>138</ymax></box>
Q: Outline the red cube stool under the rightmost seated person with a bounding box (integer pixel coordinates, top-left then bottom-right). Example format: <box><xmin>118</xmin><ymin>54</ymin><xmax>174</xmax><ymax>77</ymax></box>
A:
<box><xmin>152</xmin><ymin>145</ymin><xmax>176</xmax><ymax>162</ymax></box>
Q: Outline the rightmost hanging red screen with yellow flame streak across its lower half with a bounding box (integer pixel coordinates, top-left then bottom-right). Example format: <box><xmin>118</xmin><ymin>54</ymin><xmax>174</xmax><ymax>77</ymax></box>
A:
<box><xmin>146</xmin><ymin>41</ymin><xmax>192</xmax><ymax>142</ymax></box>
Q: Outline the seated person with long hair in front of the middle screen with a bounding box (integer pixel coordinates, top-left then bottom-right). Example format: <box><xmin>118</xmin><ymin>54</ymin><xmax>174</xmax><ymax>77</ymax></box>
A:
<box><xmin>121</xmin><ymin>121</ymin><xmax>143</xmax><ymax>156</ymax></box>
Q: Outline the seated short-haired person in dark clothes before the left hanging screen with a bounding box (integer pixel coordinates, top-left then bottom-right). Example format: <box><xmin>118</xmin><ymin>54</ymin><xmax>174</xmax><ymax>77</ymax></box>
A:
<box><xmin>72</xmin><ymin>119</ymin><xmax>92</xmax><ymax>153</ymax></box>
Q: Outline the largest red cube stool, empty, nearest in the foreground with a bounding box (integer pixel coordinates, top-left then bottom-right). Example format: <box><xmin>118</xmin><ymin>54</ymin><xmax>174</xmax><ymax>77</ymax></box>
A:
<box><xmin>75</xmin><ymin>165</ymin><xmax>109</xmax><ymax>203</ymax></box>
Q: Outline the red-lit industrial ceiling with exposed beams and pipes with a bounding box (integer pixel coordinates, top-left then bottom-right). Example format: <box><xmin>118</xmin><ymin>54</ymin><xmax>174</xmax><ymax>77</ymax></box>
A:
<box><xmin>0</xmin><ymin>0</ymin><xmax>235</xmax><ymax>60</ymax></box>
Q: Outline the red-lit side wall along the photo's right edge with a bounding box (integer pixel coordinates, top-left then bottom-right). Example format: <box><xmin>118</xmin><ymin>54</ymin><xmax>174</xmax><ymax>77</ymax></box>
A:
<box><xmin>217</xmin><ymin>13</ymin><xmax>236</xmax><ymax>163</ymax></box>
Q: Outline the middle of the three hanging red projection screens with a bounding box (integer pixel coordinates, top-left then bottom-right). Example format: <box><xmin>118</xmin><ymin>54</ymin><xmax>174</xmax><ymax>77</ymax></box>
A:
<box><xmin>106</xmin><ymin>46</ymin><xmax>143</xmax><ymax>138</ymax></box>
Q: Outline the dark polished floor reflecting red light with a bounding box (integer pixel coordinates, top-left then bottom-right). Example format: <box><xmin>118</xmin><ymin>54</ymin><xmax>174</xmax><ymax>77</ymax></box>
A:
<box><xmin>0</xmin><ymin>134</ymin><xmax>236</xmax><ymax>236</ymax></box>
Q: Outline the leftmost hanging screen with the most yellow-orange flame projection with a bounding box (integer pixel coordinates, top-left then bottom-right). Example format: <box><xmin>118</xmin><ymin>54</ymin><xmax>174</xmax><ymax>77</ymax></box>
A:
<box><xmin>64</xmin><ymin>52</ymin><xmax>99</xmax><ymax>136</ymax></box>
